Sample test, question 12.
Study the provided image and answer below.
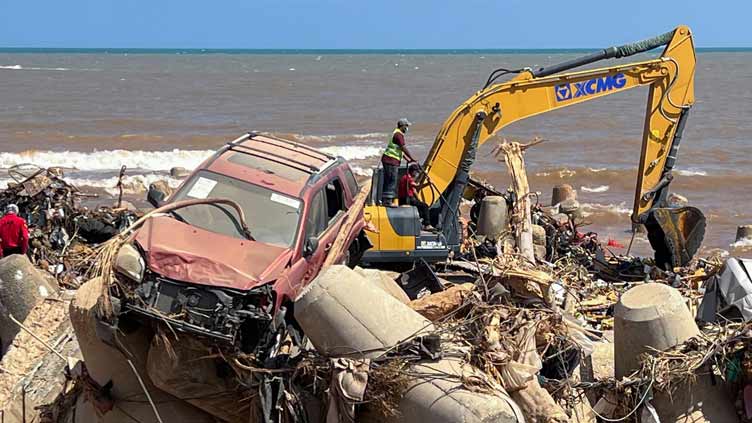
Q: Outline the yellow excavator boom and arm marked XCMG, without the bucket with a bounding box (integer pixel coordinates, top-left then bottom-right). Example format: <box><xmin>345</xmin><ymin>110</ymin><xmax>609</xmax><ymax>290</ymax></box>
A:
<box><xmin>420</xmin><ymin>26</ymin><xmax>695</xmax><ymax>222</ymax></box>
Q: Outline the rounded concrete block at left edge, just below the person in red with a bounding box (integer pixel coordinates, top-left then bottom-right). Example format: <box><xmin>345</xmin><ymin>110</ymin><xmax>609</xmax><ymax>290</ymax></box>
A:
<box><xmin>0</xmin><ymin>254</ymin><xmax>59</xmax><ymax>353</ymax></box>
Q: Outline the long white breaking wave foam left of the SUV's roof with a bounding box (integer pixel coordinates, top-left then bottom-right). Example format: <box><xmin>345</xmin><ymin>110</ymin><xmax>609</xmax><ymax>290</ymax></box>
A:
<box><xmin>0</xmin><ymin>149</ymin><xmax>213</xmax><ymax>171</ymax></box>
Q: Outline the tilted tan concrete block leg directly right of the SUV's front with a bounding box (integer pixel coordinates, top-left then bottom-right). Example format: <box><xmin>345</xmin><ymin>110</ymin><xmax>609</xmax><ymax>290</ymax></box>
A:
<box><xmin>295</xmin><ymin>266</ymin><xmax>434</xmax><ymax>358</ymax></box>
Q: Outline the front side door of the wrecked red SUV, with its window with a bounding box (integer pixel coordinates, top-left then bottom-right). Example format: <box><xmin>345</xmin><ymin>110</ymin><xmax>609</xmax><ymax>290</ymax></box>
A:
<box><xmin>303</xmin><ymin>177</ymin><xmax>346</xmax><ymax>282</ymax></box>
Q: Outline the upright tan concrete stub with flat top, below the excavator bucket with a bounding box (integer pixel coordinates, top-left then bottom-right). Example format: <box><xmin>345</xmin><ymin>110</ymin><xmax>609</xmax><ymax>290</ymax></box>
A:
<box><xmin>614</xmin><ymin>283</ymin><xmax>700</xmax><ymax>379</ymax></box>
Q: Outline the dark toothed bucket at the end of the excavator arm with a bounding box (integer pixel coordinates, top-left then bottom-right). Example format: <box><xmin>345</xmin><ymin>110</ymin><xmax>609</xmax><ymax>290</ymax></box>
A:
<box><xmin>645</xmin><ymin>207</ymin><xmax>705</xmax><ymax>270</ymax></box>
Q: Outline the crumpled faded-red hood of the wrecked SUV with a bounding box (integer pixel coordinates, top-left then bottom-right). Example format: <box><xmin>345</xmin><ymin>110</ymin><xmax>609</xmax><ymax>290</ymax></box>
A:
<box><xmin>134</xmin><ymin>216</ymin><xmax>292</xmax><ymax>290</ymax></box>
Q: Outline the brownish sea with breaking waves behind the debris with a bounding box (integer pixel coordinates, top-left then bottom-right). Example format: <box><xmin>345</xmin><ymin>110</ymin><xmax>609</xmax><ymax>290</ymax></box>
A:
<box><xmin>0</xmin><ymin>49</ymin><xmax>752</xmax><ymax>256</ymax></box>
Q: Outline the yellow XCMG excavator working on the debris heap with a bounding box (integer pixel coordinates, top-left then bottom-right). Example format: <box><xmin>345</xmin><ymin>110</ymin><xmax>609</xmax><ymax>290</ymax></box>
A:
<box><xmin>363</xmin><ymin>26</ymin><xmax>705</xmax><ymax>266</ymax></box>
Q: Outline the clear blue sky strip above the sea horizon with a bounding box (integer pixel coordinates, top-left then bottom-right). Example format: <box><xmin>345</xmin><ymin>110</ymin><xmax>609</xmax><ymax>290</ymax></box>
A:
<box><xmin>0</xmin><ymin>0</ymin><xmax>752</xmax><ymax>49</ymax></box>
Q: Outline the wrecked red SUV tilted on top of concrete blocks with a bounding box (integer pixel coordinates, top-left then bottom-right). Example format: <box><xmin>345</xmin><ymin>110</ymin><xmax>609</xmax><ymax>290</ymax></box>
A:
<box><xmin>110</xmin><ymin>133</ymin><xmax>370</xmax><ymax>352</ymax></box>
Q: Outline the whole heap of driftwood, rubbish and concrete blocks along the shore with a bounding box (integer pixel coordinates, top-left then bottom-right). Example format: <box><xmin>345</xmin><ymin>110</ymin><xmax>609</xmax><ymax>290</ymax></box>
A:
<box><xmin>0</xmin><ymin>143</ymin><xmax>752</xmax><ymax>423</ymax></box>
